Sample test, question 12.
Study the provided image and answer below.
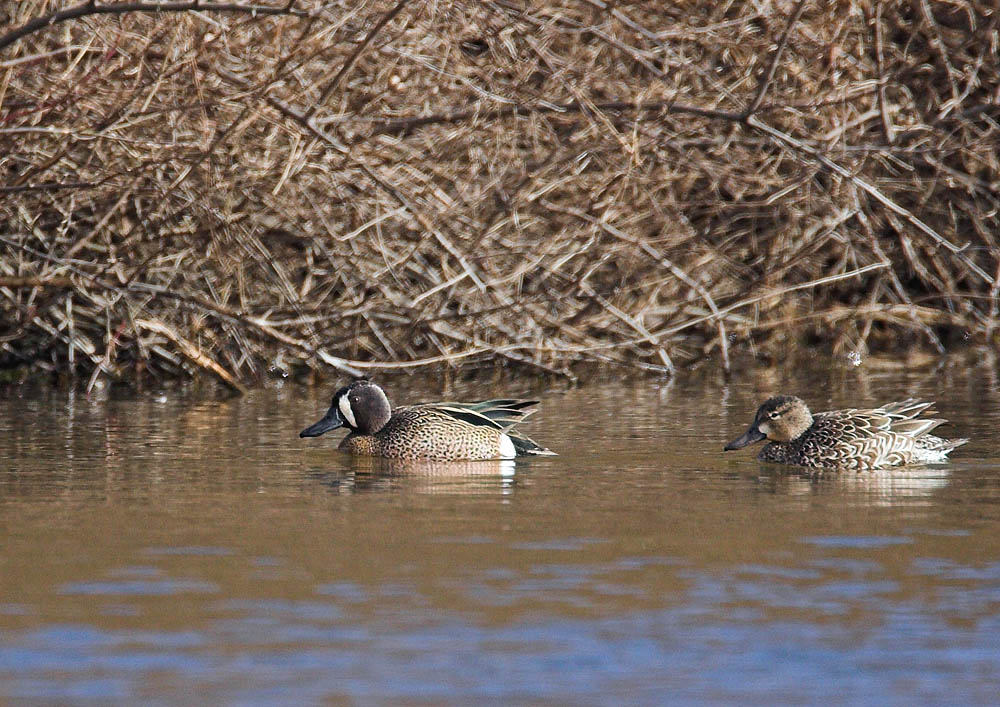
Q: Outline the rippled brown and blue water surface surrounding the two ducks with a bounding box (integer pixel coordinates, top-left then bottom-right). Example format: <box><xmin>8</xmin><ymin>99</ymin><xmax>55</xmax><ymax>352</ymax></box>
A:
<box><xmin>0</xmin><ymin>365</ymin><xmax>1000</xmax><ymax>704</ymax></box>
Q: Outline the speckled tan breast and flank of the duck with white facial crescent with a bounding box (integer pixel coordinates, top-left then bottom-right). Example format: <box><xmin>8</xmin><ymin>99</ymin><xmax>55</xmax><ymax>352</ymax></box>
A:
<box><xmin>340</xmin><ymin>405</ymin><xmax>503</xmax><ymax>461</ymax></box>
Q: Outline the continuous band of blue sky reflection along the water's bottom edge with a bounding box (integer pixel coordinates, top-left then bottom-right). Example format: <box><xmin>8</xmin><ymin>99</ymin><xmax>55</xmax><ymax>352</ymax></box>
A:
<box><xmin>0</xmin><ymin>610</ymin><xmax>1000</xmax><ymax>704</ymax></box>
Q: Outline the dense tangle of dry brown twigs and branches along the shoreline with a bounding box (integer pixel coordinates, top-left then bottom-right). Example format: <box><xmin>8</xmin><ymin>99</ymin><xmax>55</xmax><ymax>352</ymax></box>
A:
<box><xmin>0</xmin><ymin>0</ymin><xmax>1000</xmax><ymax>390</ymax></box>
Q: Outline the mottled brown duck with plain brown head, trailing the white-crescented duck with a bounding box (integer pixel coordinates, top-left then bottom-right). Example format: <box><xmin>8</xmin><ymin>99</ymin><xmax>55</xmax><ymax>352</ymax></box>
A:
<box><xmin>726</xmin><ymin>395</ymin><xmax>969</xmax><ymax>470</ymax></box>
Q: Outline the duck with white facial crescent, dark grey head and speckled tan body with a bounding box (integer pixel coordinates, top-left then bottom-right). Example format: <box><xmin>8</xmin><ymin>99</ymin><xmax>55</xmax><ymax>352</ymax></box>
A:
<box><xmin>299</xmin><ymin>380</ymin><xmax>554</xmax><ymax>461</ymax></box>
